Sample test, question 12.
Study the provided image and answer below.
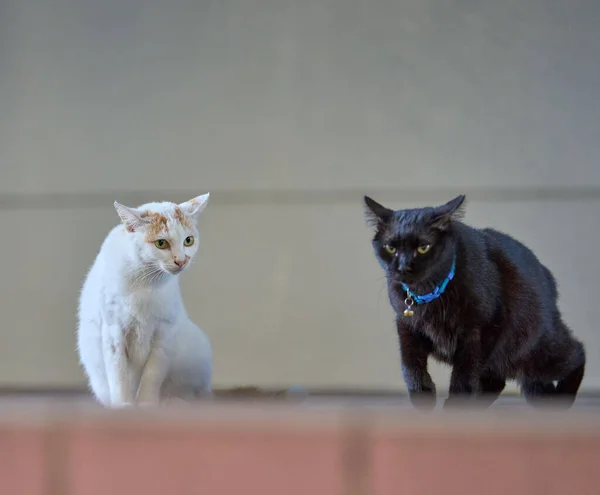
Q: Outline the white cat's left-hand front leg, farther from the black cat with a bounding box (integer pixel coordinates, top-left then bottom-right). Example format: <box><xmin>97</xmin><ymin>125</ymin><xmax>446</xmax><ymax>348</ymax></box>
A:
<box><xmin>102</xmin><ymin>325</ymin><xmax>135</xmax><ymax>407</ymax></box>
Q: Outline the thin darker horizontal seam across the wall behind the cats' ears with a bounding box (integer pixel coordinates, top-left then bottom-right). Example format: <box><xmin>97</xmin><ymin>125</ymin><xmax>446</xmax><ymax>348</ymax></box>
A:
<box><xmin>0</xmin><ymin>187</ymin><xmax>600</xmax><ymax>210</ymax></box>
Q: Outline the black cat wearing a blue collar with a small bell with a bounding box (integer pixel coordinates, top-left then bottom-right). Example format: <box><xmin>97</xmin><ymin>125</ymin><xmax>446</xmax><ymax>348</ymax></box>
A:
<box><xmin>365</xmin><ymin>196</ymin><xmax>585</xmax><ymax>409</ymax></box>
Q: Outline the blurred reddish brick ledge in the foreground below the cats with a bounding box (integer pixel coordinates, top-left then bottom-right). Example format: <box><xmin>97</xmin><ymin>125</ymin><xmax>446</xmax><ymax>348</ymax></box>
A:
<box><xmin>0</xmin><ymin>400</ymin><xmax>600</xmax><ymax>495</ymax></box>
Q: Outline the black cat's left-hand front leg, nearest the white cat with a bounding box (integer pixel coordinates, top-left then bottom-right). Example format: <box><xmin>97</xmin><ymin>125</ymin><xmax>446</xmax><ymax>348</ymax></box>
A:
<box><xmin>397</xmin><ymin>321</ymin><xmax>436</xmax><ymax>410</ymax></box>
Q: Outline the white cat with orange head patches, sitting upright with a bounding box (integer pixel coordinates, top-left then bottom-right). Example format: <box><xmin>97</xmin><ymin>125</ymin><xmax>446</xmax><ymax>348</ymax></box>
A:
<box><xmin>78</xmin><ymin>194</ymin><xmax>212</xmax><ymax>407</ymax></box>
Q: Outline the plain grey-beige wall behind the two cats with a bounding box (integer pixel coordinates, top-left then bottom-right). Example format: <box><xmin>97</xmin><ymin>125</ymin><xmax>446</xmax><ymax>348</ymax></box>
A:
<box><xmin>0</xmin><ymin>0</ymin><xmax>600</xmax><ymax>389</ymax></box>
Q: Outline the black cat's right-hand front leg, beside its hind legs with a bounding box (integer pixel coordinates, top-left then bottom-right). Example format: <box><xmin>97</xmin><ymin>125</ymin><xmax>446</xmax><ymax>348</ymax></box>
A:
<box><xmin>444</xmin><ymin>330</ymin><xmax>481</xmax><ymax>407</ymax></box>
